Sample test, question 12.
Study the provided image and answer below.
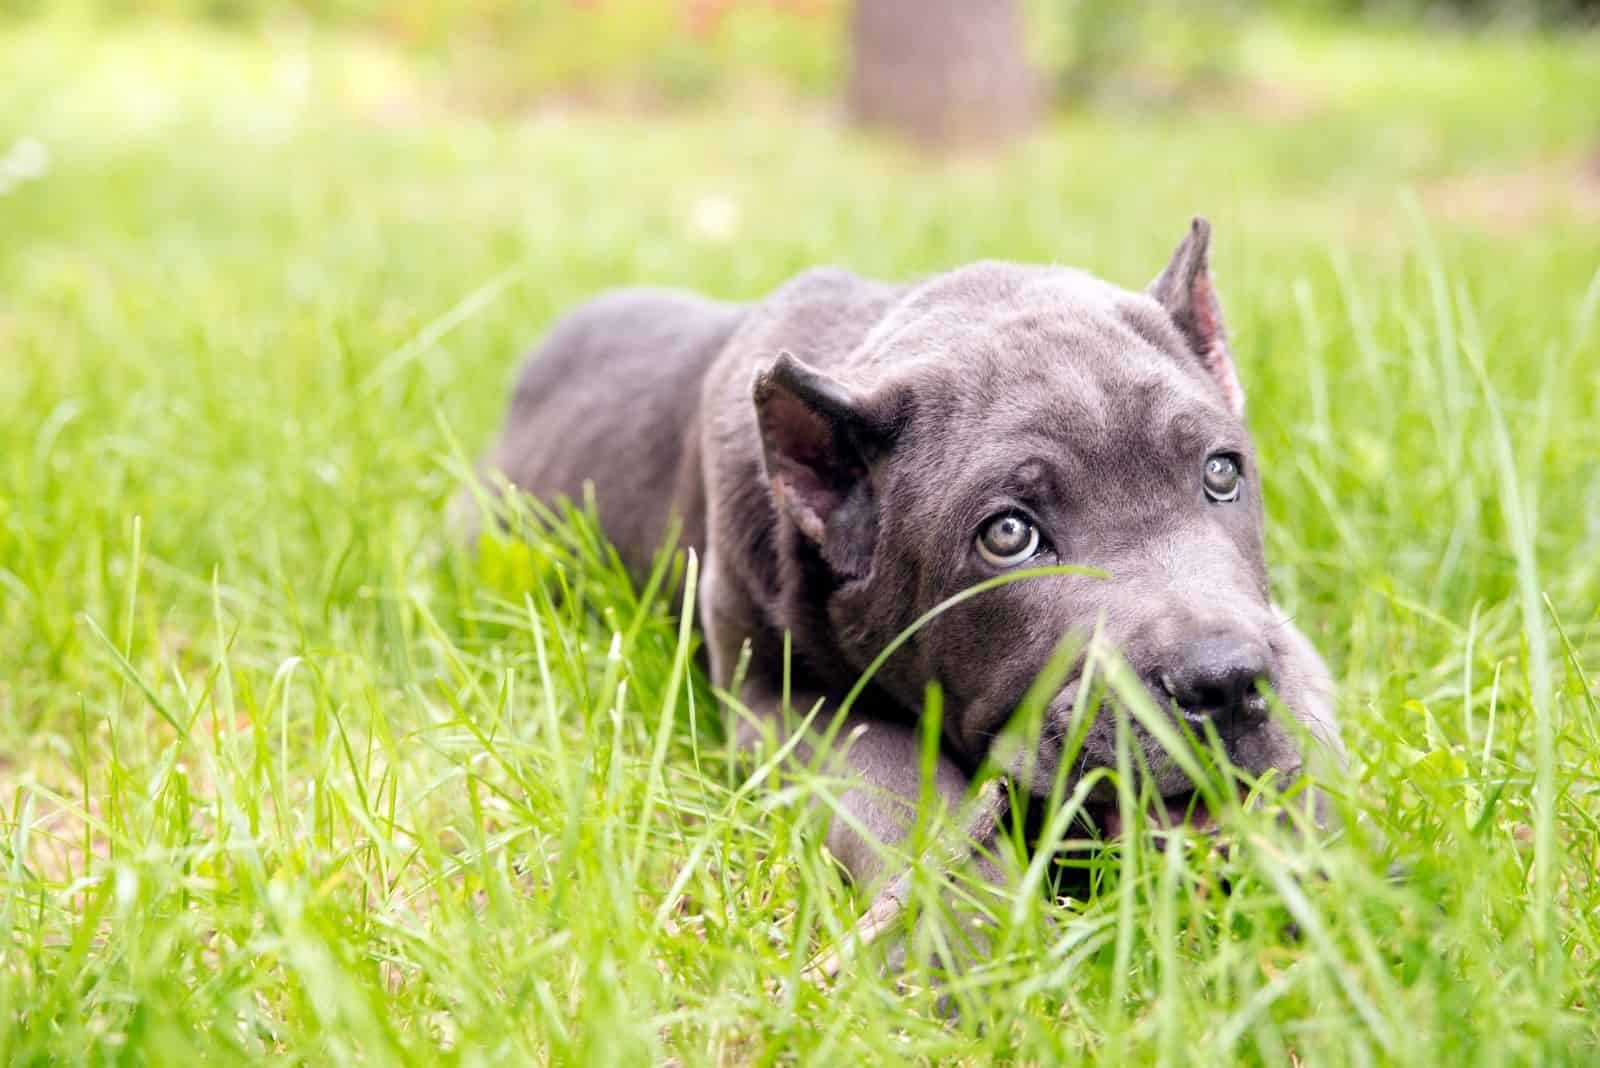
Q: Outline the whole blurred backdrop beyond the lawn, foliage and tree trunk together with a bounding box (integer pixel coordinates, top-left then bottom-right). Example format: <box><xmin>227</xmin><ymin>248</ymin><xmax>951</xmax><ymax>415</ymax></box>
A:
<box><xmin>0</xmin><ymin>0</ymin><xmax>1600</xmax><ymax>137</ymax></box>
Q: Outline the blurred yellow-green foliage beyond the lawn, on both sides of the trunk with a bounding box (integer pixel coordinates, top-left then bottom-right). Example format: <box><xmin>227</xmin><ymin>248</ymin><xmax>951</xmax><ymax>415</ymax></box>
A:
<box><xmin>0</xmin><ymin>0</ymin><xmax>1600</xmax><ymax>110</ymax></box>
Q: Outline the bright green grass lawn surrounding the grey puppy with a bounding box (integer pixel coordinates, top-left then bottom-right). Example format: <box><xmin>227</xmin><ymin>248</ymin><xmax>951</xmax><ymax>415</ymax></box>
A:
<box><xmin>0</xmin><ymin>10</ymin><xmax>1600</xmax><ymax>1065</ymax></box>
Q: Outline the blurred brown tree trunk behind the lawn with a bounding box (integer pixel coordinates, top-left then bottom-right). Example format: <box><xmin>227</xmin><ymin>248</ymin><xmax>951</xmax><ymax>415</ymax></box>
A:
<box><xmin>850</xmin><ymin>0</ymin><xmax>1038</xmax><ymax>145</ymax></box>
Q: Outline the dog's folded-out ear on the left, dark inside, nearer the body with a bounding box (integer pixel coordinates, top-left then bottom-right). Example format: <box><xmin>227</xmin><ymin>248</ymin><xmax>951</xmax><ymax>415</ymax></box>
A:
<box><xmin>754</xmin><ymin>352</ymin><xmax>890</xmax><ymax>579</ymax></box>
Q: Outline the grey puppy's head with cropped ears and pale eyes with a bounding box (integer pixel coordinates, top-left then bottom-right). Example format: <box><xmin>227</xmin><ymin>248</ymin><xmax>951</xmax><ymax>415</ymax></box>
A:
<box><xmin>755</xmin><ymin>219</ymin><xmax>1328</xmax><ymax>824</ymax></box>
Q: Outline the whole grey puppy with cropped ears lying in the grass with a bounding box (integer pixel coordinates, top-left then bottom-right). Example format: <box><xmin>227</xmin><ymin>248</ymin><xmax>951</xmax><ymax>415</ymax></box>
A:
<box><xmin>464</xmin><ymin>219</ymin><xmax>1342</xmax><ymax>883</ymax></box>
